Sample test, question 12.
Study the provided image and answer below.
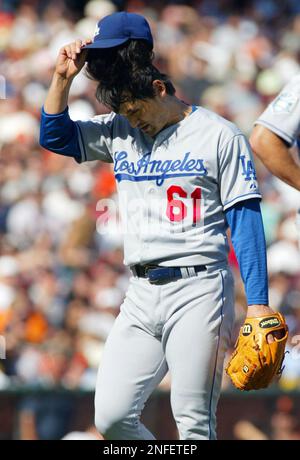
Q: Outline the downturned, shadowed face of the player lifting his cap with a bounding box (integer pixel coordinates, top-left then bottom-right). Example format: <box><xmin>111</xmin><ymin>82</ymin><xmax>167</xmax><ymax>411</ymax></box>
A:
<box><xmin>119</xmin><ymin>98</ymin><xmax>166</xmax><ymax>137</ymax></box>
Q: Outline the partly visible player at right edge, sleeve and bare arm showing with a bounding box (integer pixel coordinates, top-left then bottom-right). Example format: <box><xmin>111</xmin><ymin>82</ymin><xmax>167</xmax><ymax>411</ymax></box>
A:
<box><xmin>250</xmin><ymin>74</ymin><xmax>300</xmax><ymax>243</ymax></box>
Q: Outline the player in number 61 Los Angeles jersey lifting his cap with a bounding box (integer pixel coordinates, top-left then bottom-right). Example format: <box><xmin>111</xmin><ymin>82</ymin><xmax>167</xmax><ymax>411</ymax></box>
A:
<box><xmin>40</xmin><ymin>12</ymin><xmax>273</xmax><ymax>440</ymax></box>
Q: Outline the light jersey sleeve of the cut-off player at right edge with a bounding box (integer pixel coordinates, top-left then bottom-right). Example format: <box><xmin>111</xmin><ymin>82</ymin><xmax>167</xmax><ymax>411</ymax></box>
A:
<box><xmin>255</xmin><ymin>75</ymin><xmax>300</xmax><ymax>146</ymax></box>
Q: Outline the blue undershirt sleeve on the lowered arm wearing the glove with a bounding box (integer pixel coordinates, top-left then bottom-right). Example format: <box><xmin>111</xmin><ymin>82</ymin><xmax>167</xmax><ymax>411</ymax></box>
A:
<box><xmin>225</xmin><ymin>198</ymin><xmax>269</xmax><ymax>305</ymax></box>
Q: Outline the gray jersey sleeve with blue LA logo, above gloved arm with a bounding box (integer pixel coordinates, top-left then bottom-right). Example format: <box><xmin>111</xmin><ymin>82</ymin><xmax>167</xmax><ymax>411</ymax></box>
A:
<box><xmin>219</xmin><ymin>134</ymin><xmax>261</xmax><ymax>211</ymax></box>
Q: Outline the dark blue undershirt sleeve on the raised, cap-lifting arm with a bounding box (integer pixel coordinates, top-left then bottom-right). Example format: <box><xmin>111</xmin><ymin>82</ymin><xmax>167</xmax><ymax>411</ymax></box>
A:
<box><xmin>40</xmin><ymin>107</ymin><xmax>82</xmax><ymax>163</ymax></box>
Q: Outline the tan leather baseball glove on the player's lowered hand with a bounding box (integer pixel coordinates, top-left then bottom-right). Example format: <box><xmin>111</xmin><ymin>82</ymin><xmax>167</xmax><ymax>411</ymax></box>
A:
<box><xmin>226</xmin><ymin>313</ymin><xmax>288</xmax><ymax>391</ymax></box>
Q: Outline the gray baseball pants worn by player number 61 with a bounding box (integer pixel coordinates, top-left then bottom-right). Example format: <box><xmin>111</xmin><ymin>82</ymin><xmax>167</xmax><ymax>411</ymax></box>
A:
<box><xmin>95</xmin><ymin>267</ymin><xmax>234</xmax><ymax>440</ymax></box>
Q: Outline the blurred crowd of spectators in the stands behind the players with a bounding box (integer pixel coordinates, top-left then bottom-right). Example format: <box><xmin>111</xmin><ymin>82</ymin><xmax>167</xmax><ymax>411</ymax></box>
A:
<box><xmin>0</xmin><ymin>0</ymin><xmax>300</xmax><ymax>439</ymax></box>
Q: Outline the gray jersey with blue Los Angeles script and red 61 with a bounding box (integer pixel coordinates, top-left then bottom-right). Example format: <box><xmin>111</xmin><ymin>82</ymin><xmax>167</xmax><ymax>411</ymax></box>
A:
<box><xmin>77</xmin><ymin>107</ymin><xmax>260</xmax><ymax>266</ymax></box>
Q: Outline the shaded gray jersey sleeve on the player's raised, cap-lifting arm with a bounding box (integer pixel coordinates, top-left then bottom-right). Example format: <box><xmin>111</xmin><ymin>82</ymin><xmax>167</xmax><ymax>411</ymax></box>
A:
<box><xmin>76</xmin><ymin>113</ymin><xmax>115</xmax><ymax>163</ymax></box>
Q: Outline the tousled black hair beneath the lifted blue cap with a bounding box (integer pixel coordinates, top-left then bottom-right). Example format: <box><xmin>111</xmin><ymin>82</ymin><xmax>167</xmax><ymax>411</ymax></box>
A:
<box><xmin>86</xmin><ymin>40</ymin><xmax>175</xmax><ymax>112</ymax></box>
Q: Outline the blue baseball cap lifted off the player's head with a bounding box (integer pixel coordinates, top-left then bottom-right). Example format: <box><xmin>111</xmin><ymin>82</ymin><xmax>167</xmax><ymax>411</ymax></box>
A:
<box><xmin>83</xmin><ymin>11</ymin><xmax>153</xmax><ymax>49</ymax></box>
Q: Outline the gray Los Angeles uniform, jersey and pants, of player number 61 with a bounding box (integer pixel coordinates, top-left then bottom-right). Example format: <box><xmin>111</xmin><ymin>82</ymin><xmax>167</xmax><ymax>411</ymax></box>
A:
<box><xmin>72</xmin><ymin>107</ymin><xmax>260</xmax><ymax>439</ymax></box>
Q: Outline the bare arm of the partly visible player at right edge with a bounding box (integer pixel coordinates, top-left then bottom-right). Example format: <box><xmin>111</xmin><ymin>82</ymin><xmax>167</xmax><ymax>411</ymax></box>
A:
<box><xmin>250</xmin><ymin>125</ymin><xmax>300</xmax><ymax>190</ymax></box>
